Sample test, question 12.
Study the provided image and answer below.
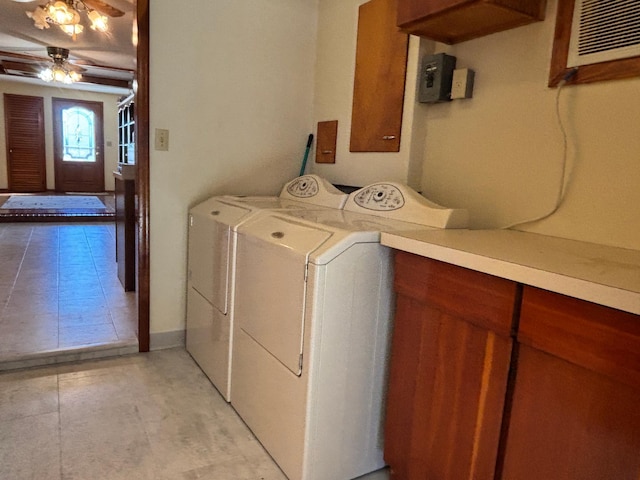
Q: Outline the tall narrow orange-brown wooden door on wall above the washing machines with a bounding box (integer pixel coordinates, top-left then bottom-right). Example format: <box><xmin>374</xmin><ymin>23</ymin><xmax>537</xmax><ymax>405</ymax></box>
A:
<box><xmin>349</xmin><ymin>0</ymin><xmax>409</xmax><ymax>152</ymax></box>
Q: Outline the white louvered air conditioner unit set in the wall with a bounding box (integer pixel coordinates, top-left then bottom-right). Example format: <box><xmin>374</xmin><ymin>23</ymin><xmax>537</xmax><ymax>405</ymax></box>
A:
<box><xmin>559</xmin><ymin>0</ymin><xmax>640</xmax><ymax>67</ymax></box>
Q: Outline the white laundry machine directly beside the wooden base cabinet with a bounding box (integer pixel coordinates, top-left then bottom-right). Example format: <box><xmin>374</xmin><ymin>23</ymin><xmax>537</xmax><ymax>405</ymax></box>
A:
<box><xmin>231</xmin><ymin>183</ymin><xmax>467</xmax><ymax>480</ymax></box>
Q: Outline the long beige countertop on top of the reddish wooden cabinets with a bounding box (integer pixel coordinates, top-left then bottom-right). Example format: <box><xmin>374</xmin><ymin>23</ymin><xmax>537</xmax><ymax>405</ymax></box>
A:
<box><xmin>381</xmin><ymin>230</ymin><xmax>640</xmax><ymax>315</ymax></box>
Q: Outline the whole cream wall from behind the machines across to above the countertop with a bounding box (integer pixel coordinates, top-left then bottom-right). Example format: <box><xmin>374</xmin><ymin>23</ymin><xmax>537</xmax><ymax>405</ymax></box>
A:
<box><xmin>312</xmin><ymin>0</ymin><xmax>640</xmax><ymax>249</ymax></box>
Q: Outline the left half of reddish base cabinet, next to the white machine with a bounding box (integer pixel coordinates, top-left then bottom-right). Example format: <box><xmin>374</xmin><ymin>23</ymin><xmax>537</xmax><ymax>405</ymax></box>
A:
<box><xmin>385</xmin><ymin>252</ymin><xmax>516</xmax><ymax>480</ymax></box>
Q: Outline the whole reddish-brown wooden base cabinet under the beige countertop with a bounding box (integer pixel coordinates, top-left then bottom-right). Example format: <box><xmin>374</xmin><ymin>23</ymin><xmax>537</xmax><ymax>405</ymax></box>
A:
<box><xmin>385</xmin><ymin>252</ymin><xmax>640</xmax><ymax>480</ymax></box>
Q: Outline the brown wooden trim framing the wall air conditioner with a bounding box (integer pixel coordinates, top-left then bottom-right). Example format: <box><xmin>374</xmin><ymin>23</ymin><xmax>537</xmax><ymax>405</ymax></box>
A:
<box><xmin>549</xmin><ymin>0</ymin><xmax>640</xmax><ymax>87</ymax></box>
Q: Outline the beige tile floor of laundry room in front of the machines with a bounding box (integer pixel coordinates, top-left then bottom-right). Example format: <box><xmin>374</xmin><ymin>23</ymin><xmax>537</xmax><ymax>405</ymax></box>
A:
<box><xmin>0</xmin><ymin>349</ymin><xmax>388</xmax><ymax>480</ymax></box>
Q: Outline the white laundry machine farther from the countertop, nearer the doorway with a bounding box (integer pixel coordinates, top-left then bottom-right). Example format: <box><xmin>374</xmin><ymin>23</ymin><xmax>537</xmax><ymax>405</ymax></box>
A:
<box><xmin>186</xmin><ymin>175</ymin><xmax>347</xmax><ymax>401</ymax></box>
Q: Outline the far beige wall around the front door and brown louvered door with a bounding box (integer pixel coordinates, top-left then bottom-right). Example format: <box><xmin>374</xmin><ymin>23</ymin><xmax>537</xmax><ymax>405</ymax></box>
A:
<box><xmin>0</xmin><ymin>80</ymin><xmax>120</xmax><ymax>191</ymax></box>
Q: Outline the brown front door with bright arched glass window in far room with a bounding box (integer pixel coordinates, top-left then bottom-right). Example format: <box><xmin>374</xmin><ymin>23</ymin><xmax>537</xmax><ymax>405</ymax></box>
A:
<box><xmin>53</xmin><ymin>98</ymin><xmax>104</xmax><ymax>192</ymax></box>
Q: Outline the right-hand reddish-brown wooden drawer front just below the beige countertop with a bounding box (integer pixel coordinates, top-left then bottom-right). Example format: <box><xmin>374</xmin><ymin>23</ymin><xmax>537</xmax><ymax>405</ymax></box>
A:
<box><xmin>518</xmin><ymin>287</ymin><xmax>640</xmax><ymax>388</ymax></box>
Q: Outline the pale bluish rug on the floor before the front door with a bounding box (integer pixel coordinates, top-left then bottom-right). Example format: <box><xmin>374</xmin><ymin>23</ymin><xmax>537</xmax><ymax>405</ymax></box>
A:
<box><xmin>0</xmin><ymin>195</ymin><xmax>115</xmax><ymax>222</ymax></box>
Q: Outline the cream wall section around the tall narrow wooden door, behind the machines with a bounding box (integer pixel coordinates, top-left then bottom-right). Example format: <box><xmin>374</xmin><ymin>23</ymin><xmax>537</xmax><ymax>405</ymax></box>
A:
<box><xmin>308</xmin><ymin>0</ymin><xmax>423</xmax><ymax>188</ymax></box>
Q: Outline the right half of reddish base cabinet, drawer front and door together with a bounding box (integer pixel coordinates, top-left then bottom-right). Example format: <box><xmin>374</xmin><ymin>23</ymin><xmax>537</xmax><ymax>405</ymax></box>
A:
<box><xmin>502</xmin><ymin>287</ymin><xmax>640</xmax><ymax>480</ymax></box>
